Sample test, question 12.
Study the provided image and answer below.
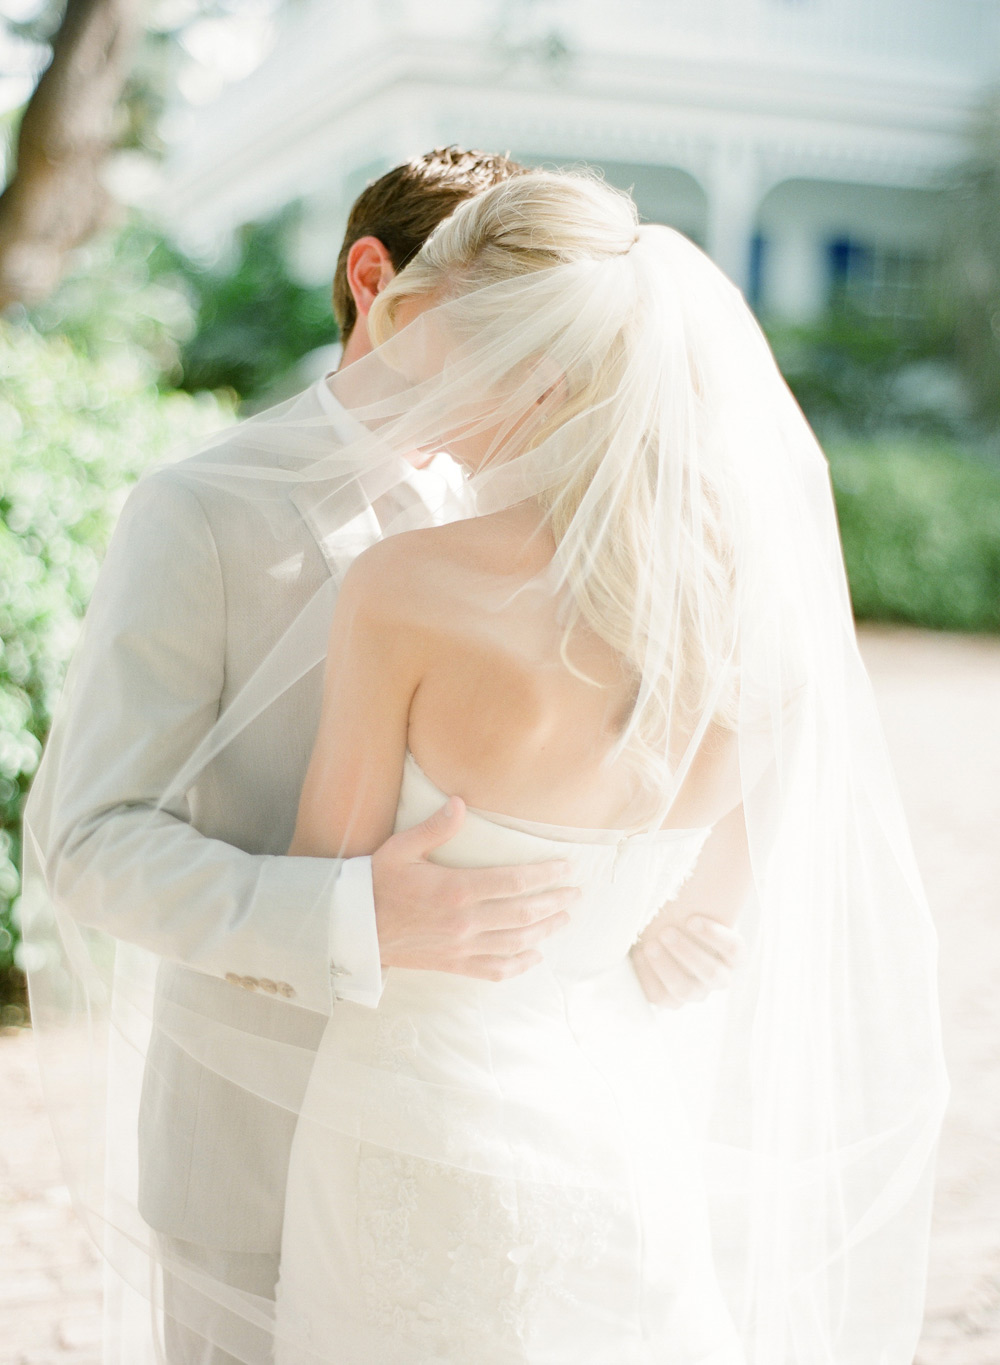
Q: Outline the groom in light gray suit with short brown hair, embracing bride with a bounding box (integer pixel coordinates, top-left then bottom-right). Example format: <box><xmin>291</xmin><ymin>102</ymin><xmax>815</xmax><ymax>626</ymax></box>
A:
<box><xmin>41</xmin><ymin>147</ymin><xmax>738</xmax><ymax>1365</ymax></box>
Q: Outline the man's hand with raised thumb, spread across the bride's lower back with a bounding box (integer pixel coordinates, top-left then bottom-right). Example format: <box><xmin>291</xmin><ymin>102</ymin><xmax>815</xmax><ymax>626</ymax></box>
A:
<box><xmin>371</xmin><ymin>797</ymin><xmax>580</xmax><ymax>981</ymax></box>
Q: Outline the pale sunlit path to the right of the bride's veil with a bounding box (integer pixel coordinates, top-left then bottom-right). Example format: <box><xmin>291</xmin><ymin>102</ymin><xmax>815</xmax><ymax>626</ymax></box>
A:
<box><xmin>862</xmin><ymin>631</ymin><xmax>1000</xmax><ymax>1365</ymax></box>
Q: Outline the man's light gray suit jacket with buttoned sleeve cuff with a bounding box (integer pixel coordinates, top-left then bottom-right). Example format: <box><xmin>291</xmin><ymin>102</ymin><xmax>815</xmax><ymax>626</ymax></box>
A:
<box><xmin>41</xmin><ymin>384</ymin><xmax>442</xmax><ymax>1252</ymax></box>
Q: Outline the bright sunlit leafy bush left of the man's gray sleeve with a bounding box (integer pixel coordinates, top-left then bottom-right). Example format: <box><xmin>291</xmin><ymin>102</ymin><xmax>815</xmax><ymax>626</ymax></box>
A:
<box><xmin>0</xmin><ymin>322</ymin><xmax>229</xmax><ymax>1015</ymax></box>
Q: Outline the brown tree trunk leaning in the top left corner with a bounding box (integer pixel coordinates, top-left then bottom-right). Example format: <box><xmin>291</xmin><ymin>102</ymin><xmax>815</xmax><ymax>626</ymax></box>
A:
<box><xmin>0</xmin><ymin>0</ymin><xmax>142</xmax><ymax>310</ymax></box>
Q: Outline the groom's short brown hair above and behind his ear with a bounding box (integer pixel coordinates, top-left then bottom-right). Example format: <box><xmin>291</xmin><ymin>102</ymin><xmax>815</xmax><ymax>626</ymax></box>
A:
<box><xmin>333</xmin><ymin>147</ymin><xmax>527</xmax><ymax>341</ymax></box>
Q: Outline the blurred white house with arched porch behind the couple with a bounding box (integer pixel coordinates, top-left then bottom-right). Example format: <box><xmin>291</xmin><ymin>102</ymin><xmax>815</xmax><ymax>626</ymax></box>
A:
<box><xmin>165</xmin><ymin>0</ymin><xmax>1000</xmax><ymax>318</ymax></box>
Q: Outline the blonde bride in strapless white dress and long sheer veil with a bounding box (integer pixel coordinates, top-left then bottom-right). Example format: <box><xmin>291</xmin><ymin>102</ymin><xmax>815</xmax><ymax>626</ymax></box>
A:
<box><xmin>259</xmin><ymin>173</ymin><xmax>937</xmax><ymax>1365</ymax></box>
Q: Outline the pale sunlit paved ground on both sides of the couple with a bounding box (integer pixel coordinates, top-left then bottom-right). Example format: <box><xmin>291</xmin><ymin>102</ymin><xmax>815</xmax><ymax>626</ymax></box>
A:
<box><xmin>0</xmin><ymin>628</ymin><xmax>1000</xmax><ymax>1365</ymax></box>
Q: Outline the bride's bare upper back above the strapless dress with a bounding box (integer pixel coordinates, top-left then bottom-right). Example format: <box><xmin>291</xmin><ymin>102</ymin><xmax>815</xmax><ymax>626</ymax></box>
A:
<box><xmin>407</xmin><ymin>504</ymin><xmax>634</xmax><ymax>826</ymax></box>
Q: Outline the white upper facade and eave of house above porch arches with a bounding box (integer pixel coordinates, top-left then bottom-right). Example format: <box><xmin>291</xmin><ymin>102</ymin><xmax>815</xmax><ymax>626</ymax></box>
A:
<box><xmin>165</xmin><ymin>0</ymin><xmax>1000</xmax><ymax>233</ymax></box>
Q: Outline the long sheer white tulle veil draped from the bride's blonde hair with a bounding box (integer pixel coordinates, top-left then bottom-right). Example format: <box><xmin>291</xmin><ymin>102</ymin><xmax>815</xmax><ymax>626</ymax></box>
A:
<box><xmin>23</xmin><ymin>173</ymin><xmax>947</xmax><ymax>1365</ymax></box>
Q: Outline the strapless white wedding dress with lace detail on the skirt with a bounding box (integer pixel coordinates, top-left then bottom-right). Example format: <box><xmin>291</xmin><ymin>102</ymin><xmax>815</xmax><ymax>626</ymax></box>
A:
<box><xmin>277</xmin><ymin>755</ymin><xmax>744</xmax><ymax>1365</ymax></box>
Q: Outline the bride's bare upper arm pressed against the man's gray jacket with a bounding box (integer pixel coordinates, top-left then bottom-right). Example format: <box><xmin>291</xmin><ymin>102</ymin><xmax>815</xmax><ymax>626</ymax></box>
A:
<box><xmin>289</xmin><ymin>536</ymin><xmax>423</xmax><ymax>857</ymax></box>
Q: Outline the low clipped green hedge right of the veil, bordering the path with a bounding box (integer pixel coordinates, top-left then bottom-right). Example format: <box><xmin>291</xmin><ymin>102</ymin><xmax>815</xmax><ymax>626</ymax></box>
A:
<box><xmin>829</xmin><ymin>441</ymin><xmax>1000</xmax><ymax>631</ymax></box>
